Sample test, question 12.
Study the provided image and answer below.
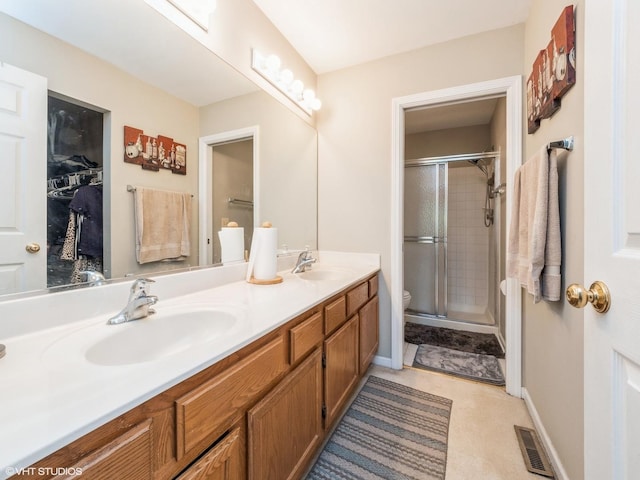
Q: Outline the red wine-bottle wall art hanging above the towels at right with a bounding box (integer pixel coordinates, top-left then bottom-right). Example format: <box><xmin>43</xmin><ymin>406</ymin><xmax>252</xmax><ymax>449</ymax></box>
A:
<box><xmin>527</xmin><ymin>5</ymin><xmax>576</xmax><ymax>133</ymax></box>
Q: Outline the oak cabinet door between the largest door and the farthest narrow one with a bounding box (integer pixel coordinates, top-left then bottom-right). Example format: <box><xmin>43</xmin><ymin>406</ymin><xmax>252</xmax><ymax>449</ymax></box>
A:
<box><xmin>324</xmin><ymin>315</ymin><xmax>360</xmax><ymax>428</ymax></box>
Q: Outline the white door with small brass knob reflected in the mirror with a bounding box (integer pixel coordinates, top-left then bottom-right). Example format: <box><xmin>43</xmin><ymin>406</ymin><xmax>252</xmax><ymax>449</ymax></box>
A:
<box><xmin>0</xmin><ymin>62</ymin><xmax>47</xmax><ymax>294</ymax></box>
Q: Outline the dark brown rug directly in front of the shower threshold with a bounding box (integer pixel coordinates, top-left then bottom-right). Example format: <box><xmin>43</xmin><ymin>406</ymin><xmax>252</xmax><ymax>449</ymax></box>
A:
<box><xmin>404</xmin><ymin>322</ymin><xmax>504</xmax><ymax>358</ymax></box>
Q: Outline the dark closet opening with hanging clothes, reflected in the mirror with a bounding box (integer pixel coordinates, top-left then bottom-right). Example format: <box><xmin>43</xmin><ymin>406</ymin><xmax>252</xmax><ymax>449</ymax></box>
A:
<box><xmin>46</xmin><ymin>92</ymin><xmax>104</xmax><ymax>287</ymax></box>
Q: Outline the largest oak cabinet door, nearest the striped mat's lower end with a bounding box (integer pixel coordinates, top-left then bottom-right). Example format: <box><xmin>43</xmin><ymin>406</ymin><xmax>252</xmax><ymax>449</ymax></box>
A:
<box><xmin>247</xmin><ymin>349</ymin><xmax>322</xmax><ymax>480</ymax></box>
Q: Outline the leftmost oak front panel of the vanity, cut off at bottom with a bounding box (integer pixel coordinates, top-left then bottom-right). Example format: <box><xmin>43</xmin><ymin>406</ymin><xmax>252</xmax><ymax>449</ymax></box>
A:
<box><xmin>69</xmin><ymin>420</ymin><xmax>153</xmax><ymax>480</ymax></box>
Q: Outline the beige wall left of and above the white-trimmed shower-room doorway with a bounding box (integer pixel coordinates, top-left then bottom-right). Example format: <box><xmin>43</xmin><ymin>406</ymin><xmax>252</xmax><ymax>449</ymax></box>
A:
<box><xmin>317</xmin><ymin>25</ymin><xmax>524</xmax><ymax>358</ymax></box>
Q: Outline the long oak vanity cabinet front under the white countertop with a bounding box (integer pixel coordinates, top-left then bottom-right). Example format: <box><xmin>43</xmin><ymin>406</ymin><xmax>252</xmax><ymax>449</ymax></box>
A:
<box><xmin>12</xmin><ymin>275</ymin><xmax>378</xmax><ymax>480</ymax></box>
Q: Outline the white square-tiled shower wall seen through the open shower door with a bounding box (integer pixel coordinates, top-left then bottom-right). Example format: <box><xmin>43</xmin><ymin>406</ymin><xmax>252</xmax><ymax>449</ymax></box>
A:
<box><xmin>447</xmin><ymin>166</ymin><xmax>490</xmax><ymax>313</ymax></box>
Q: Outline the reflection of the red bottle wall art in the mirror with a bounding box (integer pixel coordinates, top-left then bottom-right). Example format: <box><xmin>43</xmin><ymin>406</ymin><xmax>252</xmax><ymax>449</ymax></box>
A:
<box><xmin>124</xmin><ymin>125</ymin><xmax>187</xmax><ymax>175</ymax></box>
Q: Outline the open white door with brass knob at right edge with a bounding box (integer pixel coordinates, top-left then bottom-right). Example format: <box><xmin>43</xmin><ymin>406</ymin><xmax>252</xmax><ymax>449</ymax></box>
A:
<box><xmin>584</xmin><ymin>0</ymin><xmax>640</xmax><ymax>480</ymax></box>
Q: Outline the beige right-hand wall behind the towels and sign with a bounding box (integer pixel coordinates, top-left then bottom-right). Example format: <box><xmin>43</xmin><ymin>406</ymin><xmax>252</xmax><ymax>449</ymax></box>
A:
<box><xmin>522</xmin><ymin>0</ymin><xmax>588</xmax><ymax>479</ymax></box>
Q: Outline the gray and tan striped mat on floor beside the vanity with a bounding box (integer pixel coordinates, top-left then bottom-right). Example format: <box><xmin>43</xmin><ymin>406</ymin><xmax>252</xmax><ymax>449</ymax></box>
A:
<box><xmin>307</xmin><ymin>376</ymin><xmax>452</xmax><ymax>480</ymax></box>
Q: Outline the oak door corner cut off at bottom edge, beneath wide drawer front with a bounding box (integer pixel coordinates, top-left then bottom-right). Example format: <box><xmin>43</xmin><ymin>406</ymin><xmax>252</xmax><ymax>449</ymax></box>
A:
<box><xmin>176</xmin><ymin>428</ymin><xmax>242</xmax><ymax>480</ymax></box>
